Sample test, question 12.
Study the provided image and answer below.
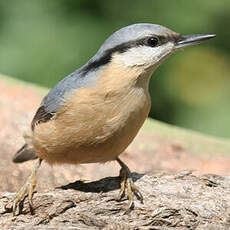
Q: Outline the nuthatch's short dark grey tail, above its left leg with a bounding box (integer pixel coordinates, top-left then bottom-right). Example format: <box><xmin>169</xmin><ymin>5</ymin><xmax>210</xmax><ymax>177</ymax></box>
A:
<box><xmin>13</xmin><ymin>144</ymin><xmax>38</xmax><ymax>163</ymax></box>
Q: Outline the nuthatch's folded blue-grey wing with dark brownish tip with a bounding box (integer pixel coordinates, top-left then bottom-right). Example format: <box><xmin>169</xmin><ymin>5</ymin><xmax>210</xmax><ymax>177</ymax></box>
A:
<box><xmin>31</xmin><ymin>69</ymin><xmax>97</xmax><ymax>130</ymax></box>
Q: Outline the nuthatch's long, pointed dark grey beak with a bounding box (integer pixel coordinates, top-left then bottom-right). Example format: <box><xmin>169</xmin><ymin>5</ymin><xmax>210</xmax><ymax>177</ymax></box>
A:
<box><xmin>175</xmin><ymin>34</ymin><xmax>216</xmax><ymax>49</ymax></box>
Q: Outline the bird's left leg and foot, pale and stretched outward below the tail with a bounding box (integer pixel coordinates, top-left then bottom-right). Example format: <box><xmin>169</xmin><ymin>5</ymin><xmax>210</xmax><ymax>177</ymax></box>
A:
<box><xmin>5</xmin><ymin>159</ymin><xmax>42</xmax><ymax>215</ymax></box>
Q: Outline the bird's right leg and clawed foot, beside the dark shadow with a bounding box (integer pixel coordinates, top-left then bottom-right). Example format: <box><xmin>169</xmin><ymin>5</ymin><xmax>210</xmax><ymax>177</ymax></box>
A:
<box><xmin>116</xmin><ymin>157</ymin><xmax>143</xmax><ymax>208</ymax></box>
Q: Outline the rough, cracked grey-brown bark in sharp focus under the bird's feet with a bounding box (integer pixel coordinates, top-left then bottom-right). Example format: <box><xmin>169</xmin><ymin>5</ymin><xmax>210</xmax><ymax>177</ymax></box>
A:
<box><xmin>0</xmin><ymin>171</ymin><xmax>230</xmax><ymax>230</ymax></box>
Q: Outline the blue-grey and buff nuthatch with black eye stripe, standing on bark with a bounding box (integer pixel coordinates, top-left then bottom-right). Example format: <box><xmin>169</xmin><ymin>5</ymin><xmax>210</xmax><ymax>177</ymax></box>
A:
<box><xmin>7</xmin><ymin>23</ymin><xmax>216</xmax><ymax>215</ymax></box>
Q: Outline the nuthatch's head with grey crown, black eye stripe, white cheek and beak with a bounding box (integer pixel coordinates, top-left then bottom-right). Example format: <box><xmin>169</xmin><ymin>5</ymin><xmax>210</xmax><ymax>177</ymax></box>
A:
<box><xmin>86</xmin><ymin>23</ymin><xmax>215</xmax><ymax>74</ymax></box>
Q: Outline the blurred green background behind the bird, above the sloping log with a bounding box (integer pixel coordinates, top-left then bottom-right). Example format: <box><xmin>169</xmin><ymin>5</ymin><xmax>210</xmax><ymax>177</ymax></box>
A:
<box><xmin>0</xmin><ymin>0</ymin><xmax>230</xmax><ymax>138</ymax></box>
